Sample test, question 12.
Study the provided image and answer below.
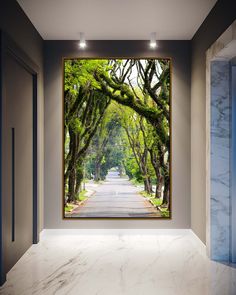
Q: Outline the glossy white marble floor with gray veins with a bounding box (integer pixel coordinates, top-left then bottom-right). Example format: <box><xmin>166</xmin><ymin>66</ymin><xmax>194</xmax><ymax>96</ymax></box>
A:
<box><xmin>0</xmin><ymin>230</ymin><xmax>236</xmax><ymax>295</ymax></box>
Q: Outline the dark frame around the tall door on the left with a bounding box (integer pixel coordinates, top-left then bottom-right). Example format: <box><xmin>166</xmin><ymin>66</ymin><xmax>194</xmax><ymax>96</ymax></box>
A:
<box><xmin>0</xmin><ymin>31</ymin><xmax>39</xmax><ymax>286</ymax></box>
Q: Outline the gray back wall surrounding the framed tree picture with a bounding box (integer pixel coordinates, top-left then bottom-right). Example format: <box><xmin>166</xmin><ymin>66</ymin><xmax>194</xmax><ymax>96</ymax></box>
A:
<box><xmin>44</xmin><ymin>41</ymin><xmax>190</xmax><ymax>228</ymax></box>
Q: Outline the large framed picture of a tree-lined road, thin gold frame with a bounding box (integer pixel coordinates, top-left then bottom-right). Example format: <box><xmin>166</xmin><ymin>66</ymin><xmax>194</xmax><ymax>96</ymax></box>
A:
<box><xmin>63</xmin><ymin>58</ymin><xmax>172</xmax><ymax>219</ymax></box>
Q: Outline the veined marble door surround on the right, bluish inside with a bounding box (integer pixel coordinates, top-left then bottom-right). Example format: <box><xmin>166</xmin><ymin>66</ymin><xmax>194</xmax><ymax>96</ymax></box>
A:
<box><xmin>205</xmin><ymin>21</ymin><xmax>236</xmax><ymax>263</ymax></box>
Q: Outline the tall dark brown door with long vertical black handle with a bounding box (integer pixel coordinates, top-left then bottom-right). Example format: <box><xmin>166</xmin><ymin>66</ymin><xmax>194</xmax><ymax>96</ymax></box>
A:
<box><xmin>2</xmin><ymin>54</ymin><xmax>33</xmax><ymax>272</ymax></box>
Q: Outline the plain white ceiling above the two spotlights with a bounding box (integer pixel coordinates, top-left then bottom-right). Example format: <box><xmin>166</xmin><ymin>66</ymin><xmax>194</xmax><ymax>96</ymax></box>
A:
<box><xmin>17</xmin><ymin>0</ymin><xmax>216</xmax><ymax>40</ymax></box>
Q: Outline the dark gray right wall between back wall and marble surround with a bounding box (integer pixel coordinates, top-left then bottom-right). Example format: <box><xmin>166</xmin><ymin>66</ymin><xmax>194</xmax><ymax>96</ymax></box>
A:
<box><xmin>191</xmin><ymin>0</ymin><xmax>236</xmax><ymax>243</ymax></box>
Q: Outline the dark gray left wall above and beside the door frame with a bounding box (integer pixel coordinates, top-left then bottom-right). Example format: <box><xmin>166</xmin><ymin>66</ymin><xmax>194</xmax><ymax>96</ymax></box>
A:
<box><xmin>0</xmin><ymin>0</ymin><xmax>44</xmax><ymax>234</ymax></box>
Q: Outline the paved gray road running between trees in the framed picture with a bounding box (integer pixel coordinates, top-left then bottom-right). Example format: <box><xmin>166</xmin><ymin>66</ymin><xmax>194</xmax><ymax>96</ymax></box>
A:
<box><xmin>71</xmin><ymin>171</ymin><xmax>160</xmax><ymax>218</ymax></box>
